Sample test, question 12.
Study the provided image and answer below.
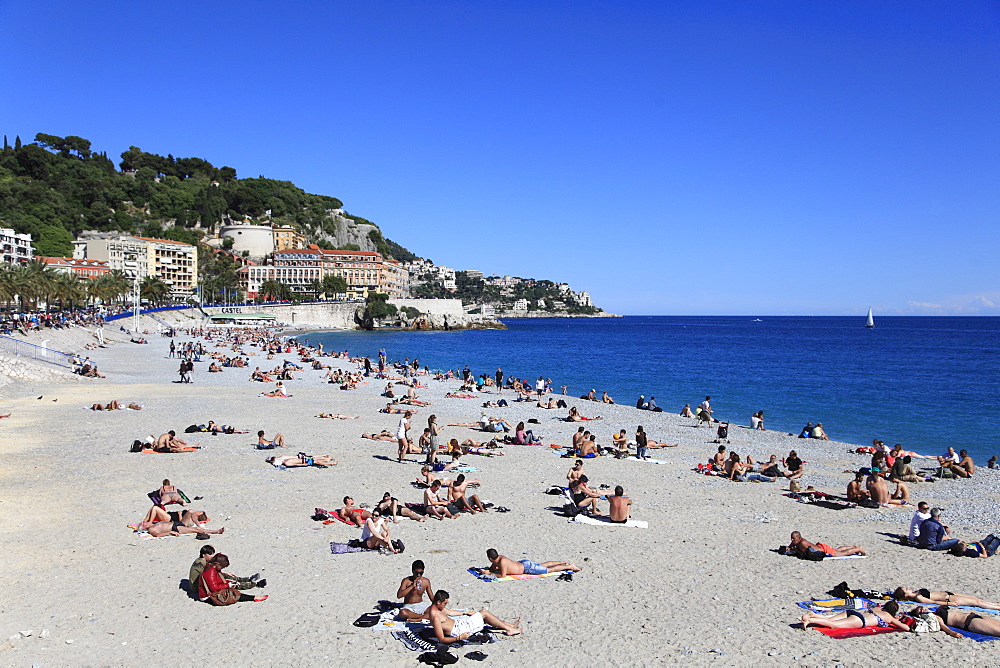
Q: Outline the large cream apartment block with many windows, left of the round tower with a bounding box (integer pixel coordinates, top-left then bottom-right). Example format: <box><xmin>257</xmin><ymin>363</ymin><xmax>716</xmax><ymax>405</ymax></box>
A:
<box><xmin>73</xmin><ymin>234</ymin><xmax>198</xmax><ymax>299</ymax></box>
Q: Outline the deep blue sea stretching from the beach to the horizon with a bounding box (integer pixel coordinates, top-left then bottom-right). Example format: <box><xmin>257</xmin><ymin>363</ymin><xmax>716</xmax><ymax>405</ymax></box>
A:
<box><xmin>304</xmin><ymin>316</ymin><xmax>1000</xmax><ymax>464</ymax></box>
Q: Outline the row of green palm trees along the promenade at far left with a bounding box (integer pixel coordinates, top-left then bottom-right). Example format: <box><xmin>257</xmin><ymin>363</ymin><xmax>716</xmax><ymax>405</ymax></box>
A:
<box><xmin>0</xmin><ymin>260</ymin><xmax>170</xmax><ymax>310</ymax></box>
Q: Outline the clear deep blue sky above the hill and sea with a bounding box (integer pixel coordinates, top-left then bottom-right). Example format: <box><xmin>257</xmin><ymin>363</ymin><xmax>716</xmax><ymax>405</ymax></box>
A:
<box><xmin>0</xmin><ymin>0</ymin><xmax>1000</xmax><ymax>315</ymax></box>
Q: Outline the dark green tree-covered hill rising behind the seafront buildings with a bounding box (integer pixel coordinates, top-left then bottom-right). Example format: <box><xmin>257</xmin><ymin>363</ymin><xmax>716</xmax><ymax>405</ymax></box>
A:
<box><xmin>0</xmin><ymin>134</ymin><xmax>413</xmax><ymax>261</ymax></box>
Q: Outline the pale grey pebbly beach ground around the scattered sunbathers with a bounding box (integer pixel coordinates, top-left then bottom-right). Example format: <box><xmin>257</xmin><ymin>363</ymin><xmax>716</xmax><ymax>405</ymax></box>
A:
<box><xmin>0</xmin><ymin>324</ymin><xmax>1000</xmax><ymax>666</ymax></box>
